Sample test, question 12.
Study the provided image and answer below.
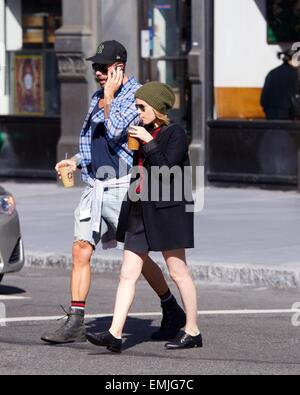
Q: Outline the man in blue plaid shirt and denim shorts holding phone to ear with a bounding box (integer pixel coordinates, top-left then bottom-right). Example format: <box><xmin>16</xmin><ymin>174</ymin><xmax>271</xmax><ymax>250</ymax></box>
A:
<box><xmin>42</xmin><ymin>41</ymin><xmax>186</xmax><ymax>344</ymax></box>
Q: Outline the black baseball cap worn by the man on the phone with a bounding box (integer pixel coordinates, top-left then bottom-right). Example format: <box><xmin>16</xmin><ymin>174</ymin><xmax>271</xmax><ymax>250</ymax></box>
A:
<box><xmin>87</xmin><ymin>40</ymin><xmax>127</xmax><ymax>64</ymax></box>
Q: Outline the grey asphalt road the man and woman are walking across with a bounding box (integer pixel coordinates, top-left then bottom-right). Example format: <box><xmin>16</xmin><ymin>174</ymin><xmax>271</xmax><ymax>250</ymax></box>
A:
<box><xmin>0</xmin><ymin>269</ymin><xmax>300</xmax><ymax>376</ymax></box>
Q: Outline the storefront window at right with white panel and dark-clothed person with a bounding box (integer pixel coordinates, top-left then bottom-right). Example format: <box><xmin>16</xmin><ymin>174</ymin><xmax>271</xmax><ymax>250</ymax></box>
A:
<box><xmin>214</xmin><ymin>0</ymin><xmax>300</xmax><ymax>120</ymax></box>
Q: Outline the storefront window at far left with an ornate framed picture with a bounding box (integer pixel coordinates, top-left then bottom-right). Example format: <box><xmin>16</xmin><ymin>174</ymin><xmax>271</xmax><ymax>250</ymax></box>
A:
<box><xmin>7</xmin><ymin>0</ymin><xmax>62</xmax><ymax>117</ymax></box>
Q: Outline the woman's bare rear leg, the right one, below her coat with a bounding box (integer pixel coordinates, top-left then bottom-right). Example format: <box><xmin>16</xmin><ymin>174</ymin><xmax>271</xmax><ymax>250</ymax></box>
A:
<box><xmin>163</xmin><ymin>250</ymin><xmax>199</xmax><ymax>336</ymax></box>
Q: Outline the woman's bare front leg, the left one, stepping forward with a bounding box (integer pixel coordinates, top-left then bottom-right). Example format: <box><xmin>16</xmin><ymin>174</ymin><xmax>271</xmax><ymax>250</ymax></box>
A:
<box><xmin>109</xmin><ymin>251</ymin><xmax>148</xmax><ymax>338</ymax></box>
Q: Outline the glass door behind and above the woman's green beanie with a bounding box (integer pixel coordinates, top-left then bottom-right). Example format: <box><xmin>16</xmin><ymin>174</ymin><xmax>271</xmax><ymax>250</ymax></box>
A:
<box><xmin>140</xmin><ymin>0</ymin><xmax>191</xmax><ymax>131</ymax></box>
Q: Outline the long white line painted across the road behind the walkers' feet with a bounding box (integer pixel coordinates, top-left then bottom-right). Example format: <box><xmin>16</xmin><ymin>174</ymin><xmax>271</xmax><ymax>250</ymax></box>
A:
<box><xmin>0</xmin><ymin>309</ymin><xmax>300</xmax><ymax>324</ymax></box>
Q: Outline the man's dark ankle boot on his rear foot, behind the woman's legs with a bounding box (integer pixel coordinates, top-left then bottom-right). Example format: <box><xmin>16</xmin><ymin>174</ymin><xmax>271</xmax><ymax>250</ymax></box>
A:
<box><xmin>151</xmin><ymin>296</ymin><xmax>186</xmax><ymax>341</ymax></box>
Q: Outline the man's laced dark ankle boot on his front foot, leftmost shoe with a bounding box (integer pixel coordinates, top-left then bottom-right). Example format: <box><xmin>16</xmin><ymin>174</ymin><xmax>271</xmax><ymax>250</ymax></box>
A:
<box><xmin>41</xmin><ymin>309</ymin><xmax>87</xmax><ymax>344</ymax></box>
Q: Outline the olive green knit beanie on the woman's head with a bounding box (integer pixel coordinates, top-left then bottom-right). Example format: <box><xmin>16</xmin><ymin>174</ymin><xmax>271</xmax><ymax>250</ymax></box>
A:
<box><xmin>135</xmin><ymin>82</ymin><xmax>176</xmax><ymax>115</ymax></box>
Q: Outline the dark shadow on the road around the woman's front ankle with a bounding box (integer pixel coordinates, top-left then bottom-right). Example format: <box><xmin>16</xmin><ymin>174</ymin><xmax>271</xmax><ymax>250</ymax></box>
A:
<box><xmin>87</xmin><ymin>317</ymin><xmax>159</xmax><ymax>351</ymax></box>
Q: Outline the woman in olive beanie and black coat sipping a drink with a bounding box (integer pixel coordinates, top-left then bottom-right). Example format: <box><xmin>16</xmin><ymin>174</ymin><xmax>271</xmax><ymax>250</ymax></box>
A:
<box><xmin>87</xmin><ymin>82</ymin><xmax>202</xmax><ymax>352</ymax></box>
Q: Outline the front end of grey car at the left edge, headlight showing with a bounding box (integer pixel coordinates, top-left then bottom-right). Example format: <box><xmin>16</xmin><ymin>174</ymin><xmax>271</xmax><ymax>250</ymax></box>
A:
<box><xmin>0</xmin><ymin>186</ymin><xmax>24</xmax><ymax>282</ymax></box>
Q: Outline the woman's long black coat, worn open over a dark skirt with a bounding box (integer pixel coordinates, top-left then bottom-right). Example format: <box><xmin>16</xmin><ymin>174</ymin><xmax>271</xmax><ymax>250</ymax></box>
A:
<box><xmin>117</xmin><ymin>124</ymin><xmax>194</xmax><ymax>251</ymax></box>
